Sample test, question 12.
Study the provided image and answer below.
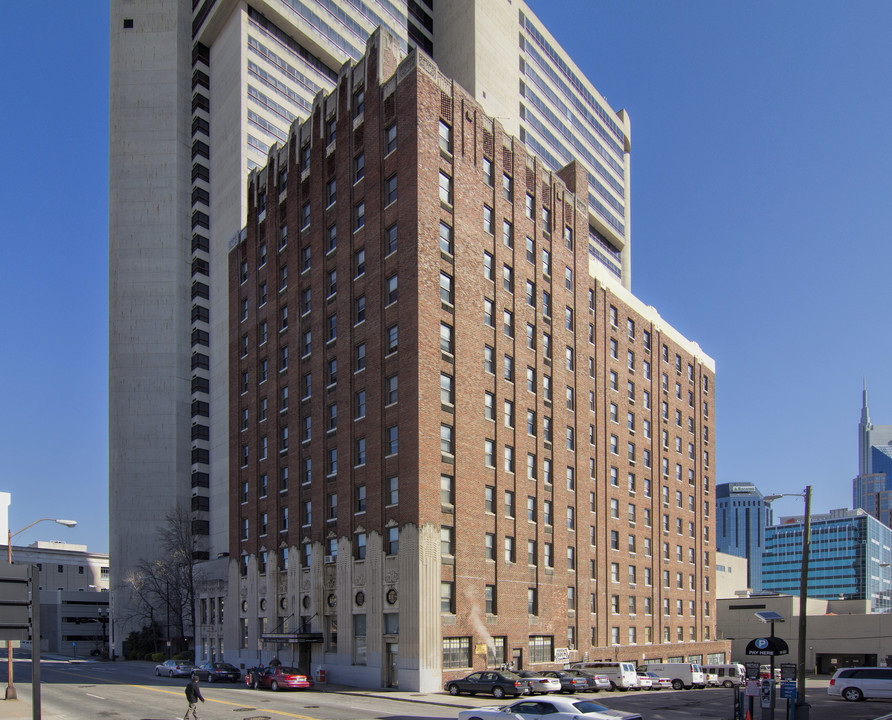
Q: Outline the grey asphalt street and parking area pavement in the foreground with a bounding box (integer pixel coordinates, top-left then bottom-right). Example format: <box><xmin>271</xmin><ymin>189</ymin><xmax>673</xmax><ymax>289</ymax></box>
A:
<box><xmin>6</xmin><ymin>660</ymin><xmax>892</xmax><ymax>720</ymax></box>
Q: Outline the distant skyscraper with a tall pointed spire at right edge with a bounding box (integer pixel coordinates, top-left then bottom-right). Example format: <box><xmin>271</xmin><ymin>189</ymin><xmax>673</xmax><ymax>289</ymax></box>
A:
<box><xmin>852</xmin><ymin>383</ymin><xmax>892</xmax><ymax>526</ymax></box>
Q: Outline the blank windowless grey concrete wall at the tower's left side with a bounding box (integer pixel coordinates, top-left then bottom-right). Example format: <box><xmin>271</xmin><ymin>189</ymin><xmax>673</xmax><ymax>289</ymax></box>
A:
<box><xmin>109</xmin><ymin>0</ymin><xmax>192</xmax><ymax>650</ymax></box>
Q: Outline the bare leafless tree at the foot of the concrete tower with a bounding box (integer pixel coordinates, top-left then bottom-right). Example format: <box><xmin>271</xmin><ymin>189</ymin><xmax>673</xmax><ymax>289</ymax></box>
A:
<box><xmin>125</xmin><ymin>508</ymin><xmax>201</xmax><ymax>652</ymax></box>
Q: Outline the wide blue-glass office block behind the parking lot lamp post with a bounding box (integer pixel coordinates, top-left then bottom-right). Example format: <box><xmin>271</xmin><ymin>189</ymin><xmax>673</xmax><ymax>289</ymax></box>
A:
<box><xmin>762</xmin><ymin>509</ymin><xmax>892</xmax><ymax>612</ymax></box>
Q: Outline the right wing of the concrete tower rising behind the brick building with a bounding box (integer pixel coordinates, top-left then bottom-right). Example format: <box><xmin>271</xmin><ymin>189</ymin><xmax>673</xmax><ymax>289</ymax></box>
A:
<box><xmin>434</xmin><ymin>0</ymin><xmax>631</xmax><ymax>289</ymax></box>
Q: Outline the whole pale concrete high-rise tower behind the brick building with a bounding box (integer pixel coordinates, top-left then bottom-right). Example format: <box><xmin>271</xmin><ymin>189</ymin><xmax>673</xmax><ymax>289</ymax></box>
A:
<box><xmin>109</xmin><ymin>0</ymin><xmax>631</xmax><ymax>652</ymax></box>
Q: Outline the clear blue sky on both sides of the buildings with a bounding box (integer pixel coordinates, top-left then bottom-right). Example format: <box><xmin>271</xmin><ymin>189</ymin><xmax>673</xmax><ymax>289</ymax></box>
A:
<box><xmin>0</xmin><ymin>0</ymin><xmax>892</xmax><ymax>551</ymax></box>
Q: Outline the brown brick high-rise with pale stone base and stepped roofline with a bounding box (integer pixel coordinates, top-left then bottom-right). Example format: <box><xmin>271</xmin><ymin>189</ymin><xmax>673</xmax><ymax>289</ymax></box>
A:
<box><xmin>221</xmin><ymin>31</ymin><xmax>730</xmax><ymax>690</ymax></box>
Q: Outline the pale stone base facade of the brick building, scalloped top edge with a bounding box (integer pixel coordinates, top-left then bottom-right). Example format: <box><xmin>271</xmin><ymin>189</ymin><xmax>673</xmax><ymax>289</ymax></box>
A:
<box><xmin>206</xmin><ymin>525</ymin><xmax>442</xmax><ymax>692</ymax></box>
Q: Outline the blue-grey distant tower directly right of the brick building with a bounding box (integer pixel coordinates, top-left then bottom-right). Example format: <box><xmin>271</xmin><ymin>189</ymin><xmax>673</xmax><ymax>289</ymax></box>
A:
<box><xmin>715</xmin><ymin>482</ymin><xmax>772</xmax><ymax>592</ymax></box>
